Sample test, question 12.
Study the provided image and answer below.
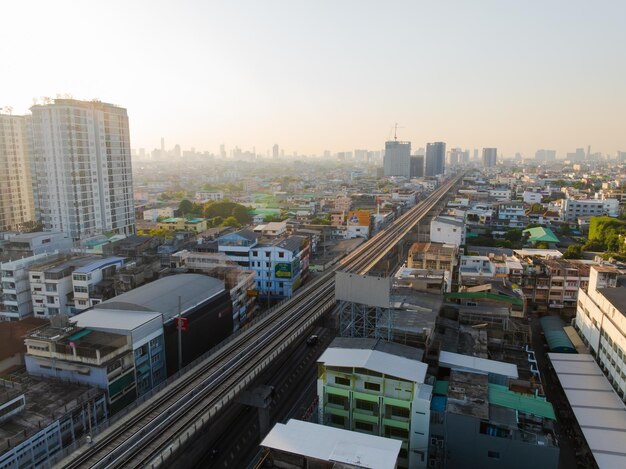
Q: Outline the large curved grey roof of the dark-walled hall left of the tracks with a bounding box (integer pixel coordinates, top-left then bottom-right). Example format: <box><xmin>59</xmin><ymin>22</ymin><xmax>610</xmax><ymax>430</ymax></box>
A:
<box><xmin>94</xmin><ymin>274</ymin><xmax>224</xmax><ymax>321</ymax></box>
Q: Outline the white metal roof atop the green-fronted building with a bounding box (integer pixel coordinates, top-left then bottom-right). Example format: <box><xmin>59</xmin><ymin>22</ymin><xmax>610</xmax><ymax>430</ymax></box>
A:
<box><xmin>318</xmin><ymin>347</ymin><xmax>428</xmax><ymax>383</ymax></box>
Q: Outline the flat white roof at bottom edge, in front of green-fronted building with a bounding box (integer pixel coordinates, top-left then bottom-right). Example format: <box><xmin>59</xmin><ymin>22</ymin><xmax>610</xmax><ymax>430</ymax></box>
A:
<box><xmin>261</xmin><ymin>419</ymin><xmax>402</xmax><ymax>469</ymax></box>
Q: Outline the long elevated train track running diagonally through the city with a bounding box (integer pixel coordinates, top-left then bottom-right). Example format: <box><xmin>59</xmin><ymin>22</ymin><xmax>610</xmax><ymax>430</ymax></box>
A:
<box><xmin>58</xmin><ymin>176</ymin><xmax>461</xmax><ymax>468</ymax></box>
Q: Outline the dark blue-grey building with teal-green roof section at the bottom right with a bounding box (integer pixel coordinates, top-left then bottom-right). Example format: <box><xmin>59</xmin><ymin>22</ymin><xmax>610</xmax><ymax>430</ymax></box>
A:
<box><xmin>429</xmin><ymin>370</ymin><xmax>560</xmax><ymax>469</ymax></box>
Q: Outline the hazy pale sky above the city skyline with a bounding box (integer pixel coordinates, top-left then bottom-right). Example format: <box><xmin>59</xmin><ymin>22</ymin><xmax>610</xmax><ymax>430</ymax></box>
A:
<box><xmin>0</xmin><ymin>0</ymin><xmax>626</xmax><ymax>157</ymax></box>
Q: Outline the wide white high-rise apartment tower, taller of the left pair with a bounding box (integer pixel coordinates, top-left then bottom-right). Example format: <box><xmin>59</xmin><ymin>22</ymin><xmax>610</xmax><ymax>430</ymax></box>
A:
<box><xmin>31</xmin><ymin>99</ymin><xmax>135</xmax><ymax>239</ymax></box>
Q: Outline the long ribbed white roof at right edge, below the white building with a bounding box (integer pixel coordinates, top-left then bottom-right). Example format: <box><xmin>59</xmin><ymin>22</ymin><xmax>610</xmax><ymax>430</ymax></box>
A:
<box><xmin>548</xmin><ymin>353</ymin><xmax>626</xmax><ymax>469</ymax></box>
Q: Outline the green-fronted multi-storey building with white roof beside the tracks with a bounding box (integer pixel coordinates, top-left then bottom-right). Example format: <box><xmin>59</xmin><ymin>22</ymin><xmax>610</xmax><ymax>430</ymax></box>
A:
<box><xmin>317</xmin><ymin>338</ymin><xmax>432</xmax><ymax>468</ymax></box>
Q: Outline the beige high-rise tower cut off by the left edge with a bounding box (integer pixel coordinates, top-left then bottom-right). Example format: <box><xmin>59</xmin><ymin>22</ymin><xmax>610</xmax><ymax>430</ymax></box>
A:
<box><xmin>0</xmin><ymin>114</ymin><xmax>35</xmax><ymax>231</ymax></box>
